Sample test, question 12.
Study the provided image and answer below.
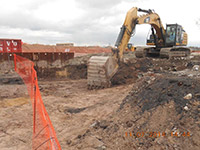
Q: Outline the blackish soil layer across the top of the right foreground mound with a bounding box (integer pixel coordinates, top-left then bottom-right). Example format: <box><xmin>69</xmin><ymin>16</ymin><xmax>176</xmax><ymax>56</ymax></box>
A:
<box><xmin>121</xmin><ymin>77</ymin><xmax>200</xmax><ymax>113</ymax></box>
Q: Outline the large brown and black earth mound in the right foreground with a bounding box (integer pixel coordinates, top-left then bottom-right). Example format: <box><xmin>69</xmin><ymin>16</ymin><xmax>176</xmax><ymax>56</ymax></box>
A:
<box><xmin>73</xmin><ymin>74</ymin><xmax>200</xmax><ymax>150</ymax></box>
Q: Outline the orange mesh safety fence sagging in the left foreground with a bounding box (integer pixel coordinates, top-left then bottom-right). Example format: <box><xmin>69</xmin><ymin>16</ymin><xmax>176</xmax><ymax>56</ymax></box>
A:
<box><xmin>14</xmin><ymin>54</ymin><xmax>61</xmax><ymax>150</ymax></box>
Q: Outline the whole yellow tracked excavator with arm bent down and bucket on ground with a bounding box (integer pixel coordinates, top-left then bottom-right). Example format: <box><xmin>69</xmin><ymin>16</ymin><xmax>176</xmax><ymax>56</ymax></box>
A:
<box><xmin>87</xmin><ymin>7</ymin><xmax>190</xmax><ymax>89</ymax></box>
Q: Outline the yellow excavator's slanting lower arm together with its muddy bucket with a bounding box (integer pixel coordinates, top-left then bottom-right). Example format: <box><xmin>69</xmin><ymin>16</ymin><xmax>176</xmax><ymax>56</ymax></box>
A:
<box><xmin>87</xmin><ymin>7</ymin><xmax>138</xmax><ymax>89</ymax></box>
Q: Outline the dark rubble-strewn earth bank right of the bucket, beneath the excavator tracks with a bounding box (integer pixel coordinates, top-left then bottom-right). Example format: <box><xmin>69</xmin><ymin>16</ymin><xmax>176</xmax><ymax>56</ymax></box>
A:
<box><xmin>111</xmin><ymin>55</ymin><xmax>193</xmax><ymax>85</ymax></box>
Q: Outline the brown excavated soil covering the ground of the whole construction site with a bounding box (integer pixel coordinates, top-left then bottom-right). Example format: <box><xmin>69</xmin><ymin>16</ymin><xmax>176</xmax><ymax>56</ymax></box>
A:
<box><xmin>0</xmin><ymin>52</ymin><xmax>200</xmax><ymax>150</ymax></box>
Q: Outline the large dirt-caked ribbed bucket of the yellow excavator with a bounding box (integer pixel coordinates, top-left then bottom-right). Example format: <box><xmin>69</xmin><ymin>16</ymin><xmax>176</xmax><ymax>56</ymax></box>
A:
<box><xmin>87</xmin><ymin>56</ymin><xmax>118</xmax><ymax>89</ymax></box>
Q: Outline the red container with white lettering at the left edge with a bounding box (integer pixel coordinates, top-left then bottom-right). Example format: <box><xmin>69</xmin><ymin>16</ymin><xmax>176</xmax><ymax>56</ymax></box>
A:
<box><xmin>0</xmin><ymin>39</ymin><xmax>22</xmax><ymax>53</ymax></box>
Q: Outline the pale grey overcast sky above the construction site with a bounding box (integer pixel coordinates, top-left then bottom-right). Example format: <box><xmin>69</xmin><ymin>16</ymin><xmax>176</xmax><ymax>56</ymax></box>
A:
<box><xmin>0</xmin><ymin>0</ymin><xmax>200</xmax><ymax>46</ymax></box>
